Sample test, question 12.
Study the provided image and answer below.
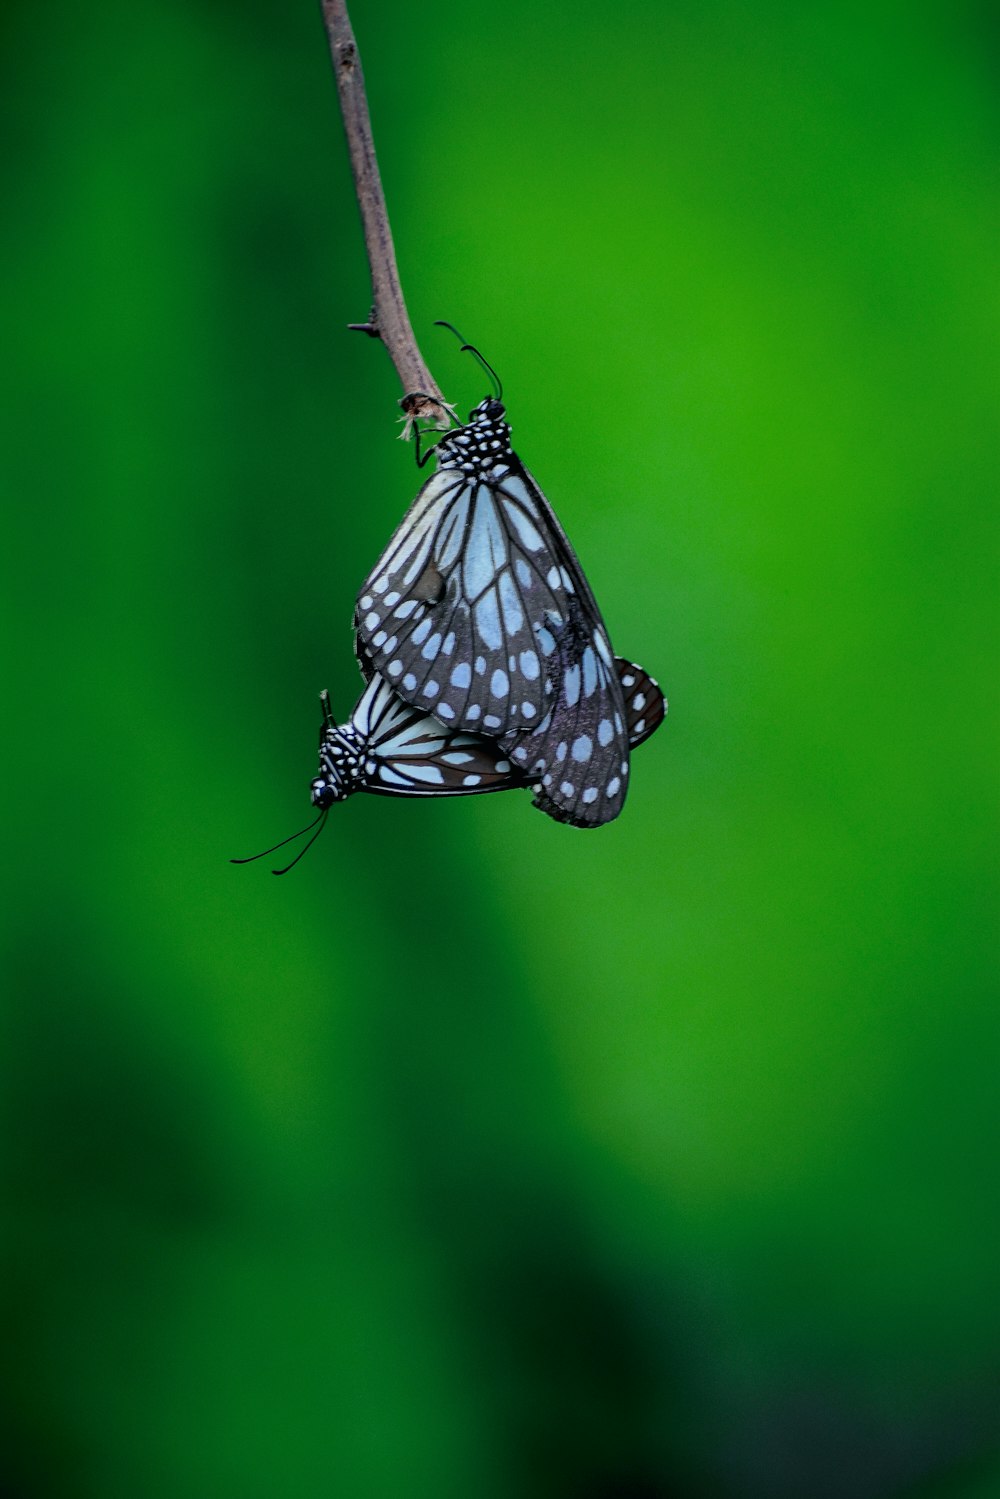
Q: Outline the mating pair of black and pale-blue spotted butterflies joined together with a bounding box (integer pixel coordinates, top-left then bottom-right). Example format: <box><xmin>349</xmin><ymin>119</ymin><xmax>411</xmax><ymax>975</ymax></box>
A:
<box><xmin>234</xmin><ymin>324</ymin><xmax>666</xmax><ymax>872</ymax></box>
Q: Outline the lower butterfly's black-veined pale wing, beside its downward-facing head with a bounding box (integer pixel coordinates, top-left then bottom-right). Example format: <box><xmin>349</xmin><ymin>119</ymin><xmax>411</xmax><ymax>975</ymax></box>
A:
<box><xmin>351</xmin><ymin>676</ymin><xmax>526</xmax><ymax>796</ymax></box>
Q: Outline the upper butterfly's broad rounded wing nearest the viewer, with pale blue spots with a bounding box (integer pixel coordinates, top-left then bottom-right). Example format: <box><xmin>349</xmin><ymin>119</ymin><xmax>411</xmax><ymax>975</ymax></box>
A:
<box><xmin>355</xmin><ymin>451</ymin><xmax>610</xmax><ymax>735</ymax></box>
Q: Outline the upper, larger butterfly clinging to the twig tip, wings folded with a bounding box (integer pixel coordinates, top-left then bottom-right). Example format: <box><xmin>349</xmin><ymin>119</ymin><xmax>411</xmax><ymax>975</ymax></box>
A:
<box><xmin>355</xmin><ymin>374</ymin><xmax>663</xmax><ymax>827</ymax></box>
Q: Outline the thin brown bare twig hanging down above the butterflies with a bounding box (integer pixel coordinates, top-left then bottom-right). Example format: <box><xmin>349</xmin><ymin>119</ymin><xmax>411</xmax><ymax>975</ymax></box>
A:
<box><xmin>322</xmin><ymin>0</ymin><xmax>450</xmax><ymax>432</ymax></box>
